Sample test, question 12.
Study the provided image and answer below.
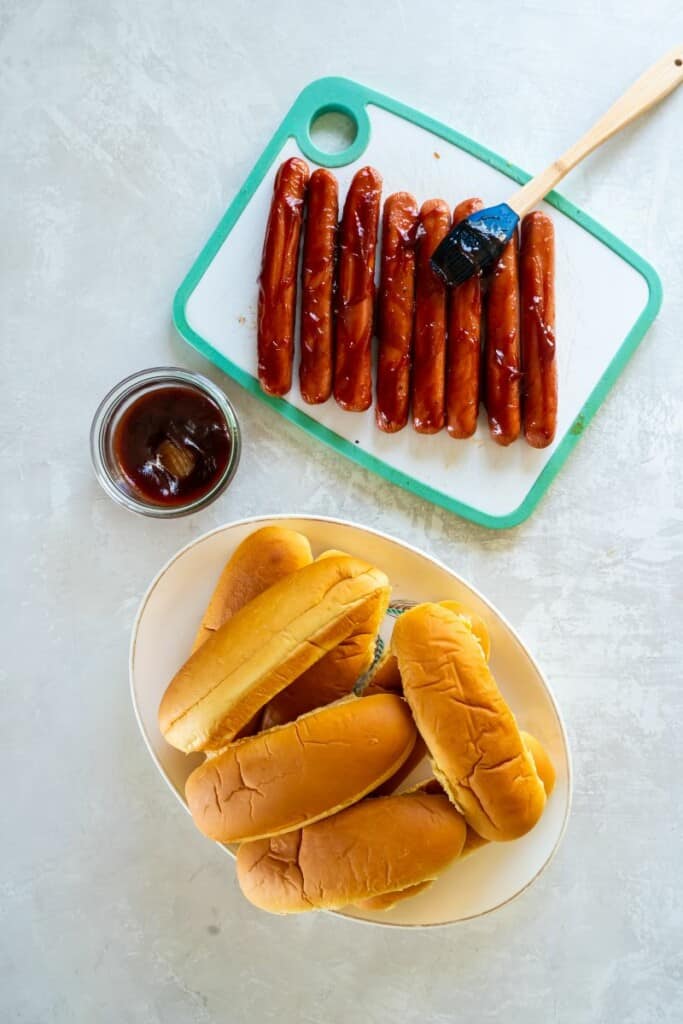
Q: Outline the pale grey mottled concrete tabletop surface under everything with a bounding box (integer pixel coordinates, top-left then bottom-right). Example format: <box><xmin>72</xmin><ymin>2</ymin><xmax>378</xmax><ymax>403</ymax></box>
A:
<box><xmin>0</xmin><ymin>0</ymin><xmax>683</xmax><ymax>1024</ymax></box>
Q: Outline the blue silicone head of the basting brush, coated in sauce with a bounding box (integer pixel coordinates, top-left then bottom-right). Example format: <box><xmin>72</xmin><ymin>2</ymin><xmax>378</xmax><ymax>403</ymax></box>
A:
<box><xmin>431</xmin><ymin>203</ymin><xmax>519</xmax><ymax>285</ymax></box>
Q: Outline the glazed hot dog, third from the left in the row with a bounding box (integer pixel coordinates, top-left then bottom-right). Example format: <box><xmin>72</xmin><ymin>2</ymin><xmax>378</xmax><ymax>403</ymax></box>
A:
<box><xmin>334</xmin><ymin>167</ymin><xmax>382</xmax><ymax>413</ymax></box>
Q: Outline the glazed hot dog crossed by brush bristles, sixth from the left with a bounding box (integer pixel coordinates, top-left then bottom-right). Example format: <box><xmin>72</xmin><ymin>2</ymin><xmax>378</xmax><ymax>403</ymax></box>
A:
<box><xmin>445</xmin><ymin>199</ymin><xmax>483</xmax><ymax>437</ymax></box>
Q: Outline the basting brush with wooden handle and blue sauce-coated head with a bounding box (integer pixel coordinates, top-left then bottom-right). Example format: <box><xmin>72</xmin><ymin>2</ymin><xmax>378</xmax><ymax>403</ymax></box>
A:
<box><xmin>431</xmin><ymin>46</ymin><xmax>683</xmax><ymax>285</ymax></box>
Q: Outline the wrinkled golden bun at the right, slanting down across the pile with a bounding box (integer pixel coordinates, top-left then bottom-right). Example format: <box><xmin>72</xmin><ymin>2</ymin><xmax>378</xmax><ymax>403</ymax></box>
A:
<box><xmin>392</xmin><ymin>604</ymin><xmax>546</xmax><ymax>841</ymax></box>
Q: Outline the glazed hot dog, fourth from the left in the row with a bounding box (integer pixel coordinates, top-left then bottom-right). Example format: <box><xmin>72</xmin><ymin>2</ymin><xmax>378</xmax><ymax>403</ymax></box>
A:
<box><xmin>375</xmin><ymin>193</ymin><xmax>418</xmax><ymax>433</ymax></box>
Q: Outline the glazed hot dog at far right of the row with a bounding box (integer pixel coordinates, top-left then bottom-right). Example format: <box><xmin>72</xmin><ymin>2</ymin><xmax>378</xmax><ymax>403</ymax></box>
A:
<box><xmin>519</xmin><ymin>211</ymin><xmax>557</xmax><ymax>447</ymax></box>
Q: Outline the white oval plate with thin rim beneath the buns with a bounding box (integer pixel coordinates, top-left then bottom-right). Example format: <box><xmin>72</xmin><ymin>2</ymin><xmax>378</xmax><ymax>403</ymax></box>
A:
<box><xmin>130</xmin><ymin>515</ymin><xmax>571</xmax><ymax>927</ymax></box>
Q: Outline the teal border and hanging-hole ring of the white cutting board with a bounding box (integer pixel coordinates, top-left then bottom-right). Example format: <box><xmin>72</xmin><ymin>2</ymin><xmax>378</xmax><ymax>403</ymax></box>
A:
<box><xmin>173</xmin><ymin>78</ymin><xmax>663</xmax><ymax>529</ymax></box>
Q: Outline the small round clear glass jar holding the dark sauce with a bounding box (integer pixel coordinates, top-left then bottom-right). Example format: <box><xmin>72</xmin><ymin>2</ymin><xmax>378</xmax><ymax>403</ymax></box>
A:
<box><xmin>90</xmin><ymin>367</ymin><xmax>242</xmax><ymax>519</ymax></box>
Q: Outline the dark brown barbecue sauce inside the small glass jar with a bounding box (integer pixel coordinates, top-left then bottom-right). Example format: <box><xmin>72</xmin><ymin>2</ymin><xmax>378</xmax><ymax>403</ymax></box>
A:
<box><xmin>113</xmin><ymin>384</ymin><xmax>231</xmax><ymax>506</ymax></box>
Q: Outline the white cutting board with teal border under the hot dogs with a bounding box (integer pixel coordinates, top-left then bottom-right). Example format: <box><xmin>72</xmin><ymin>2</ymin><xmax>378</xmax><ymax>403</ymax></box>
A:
<box><xmin>174</xmin><ymin>78</ymin><xmax>661</xmax><ymax>528</ymax></box>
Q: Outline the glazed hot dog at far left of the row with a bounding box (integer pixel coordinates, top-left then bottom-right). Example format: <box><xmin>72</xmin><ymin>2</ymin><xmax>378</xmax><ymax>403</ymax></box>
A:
<box><xmin>258</xmin><ymin>157</ymin><xmax>308</xmax><ymax>394</ymax></box>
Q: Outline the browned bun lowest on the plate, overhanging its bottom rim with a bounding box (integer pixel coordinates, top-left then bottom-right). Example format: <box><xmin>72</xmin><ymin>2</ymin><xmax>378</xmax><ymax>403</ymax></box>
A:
<box><xmin>238</xmin><ymin>790</ymin><xmax>466</xmax><ymax>913</ymax></box>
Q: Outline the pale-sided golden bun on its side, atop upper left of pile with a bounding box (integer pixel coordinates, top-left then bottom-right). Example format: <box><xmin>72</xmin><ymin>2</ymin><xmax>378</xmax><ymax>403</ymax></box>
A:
<box><xmin>159</xmin><ymin>556</ymin><xmax>390</xmax><ymax>753</ymax></box>
